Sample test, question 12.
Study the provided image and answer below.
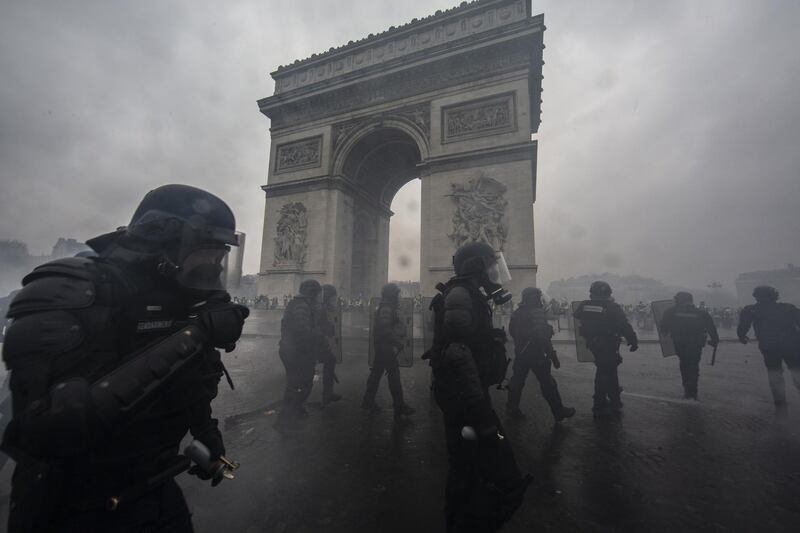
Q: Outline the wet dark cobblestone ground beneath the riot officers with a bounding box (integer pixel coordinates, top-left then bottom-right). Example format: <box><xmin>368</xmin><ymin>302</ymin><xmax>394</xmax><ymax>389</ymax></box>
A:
<box><xmin>0</xmin><ymin>316</ymin><xmax>800</xmax><ymax>533</ymax></box>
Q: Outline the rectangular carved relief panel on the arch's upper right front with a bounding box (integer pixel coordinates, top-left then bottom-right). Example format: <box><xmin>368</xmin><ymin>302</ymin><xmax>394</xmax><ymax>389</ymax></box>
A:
<box><xmin>442</xmin><ymin>93</ymin><xmax>517</xmax><ymax>143</ymax></box>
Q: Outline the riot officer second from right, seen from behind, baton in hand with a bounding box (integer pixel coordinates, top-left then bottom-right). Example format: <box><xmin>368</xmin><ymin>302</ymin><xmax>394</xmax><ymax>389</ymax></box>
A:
<box><xmin>661</xmin><ymin>292</ymin><xmax>719</xmax><ymax>400</ymax></box>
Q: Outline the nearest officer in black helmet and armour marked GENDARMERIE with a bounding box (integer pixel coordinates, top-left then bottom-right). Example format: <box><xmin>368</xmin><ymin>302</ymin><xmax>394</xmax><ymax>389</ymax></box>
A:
<box><xmin>3</xmin><ymin>185</ymin><xmax>248</xmax><ymax>533</ymax></box>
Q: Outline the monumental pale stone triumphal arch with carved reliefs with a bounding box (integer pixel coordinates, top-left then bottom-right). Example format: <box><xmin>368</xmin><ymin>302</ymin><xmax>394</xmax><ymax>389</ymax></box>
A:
<box><xmin>258</xmin><ymin>0</ymin><xmax>545</xmax><ymax>296</ymax></box>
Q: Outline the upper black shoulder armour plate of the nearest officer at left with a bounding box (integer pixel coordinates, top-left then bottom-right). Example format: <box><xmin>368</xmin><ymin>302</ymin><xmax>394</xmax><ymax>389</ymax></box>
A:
<box><xmin>8</xmin><ymin>271</ymin><xmax>96</xmax><ymax>318</ymax></box>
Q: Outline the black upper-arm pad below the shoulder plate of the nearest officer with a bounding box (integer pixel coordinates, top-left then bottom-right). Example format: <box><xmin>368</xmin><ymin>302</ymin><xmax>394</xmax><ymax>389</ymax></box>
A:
<box><xmin>3</xmin><ymin>311</ymin><xmax>85</xmax><ymax>369</ymax></box>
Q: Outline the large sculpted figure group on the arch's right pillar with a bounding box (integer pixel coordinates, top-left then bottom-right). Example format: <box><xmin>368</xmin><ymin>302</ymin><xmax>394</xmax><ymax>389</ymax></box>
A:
<box><xmin>447</xmin><ymin>176</ymin><xmax>508</xmax><ymax>250</ymax></box>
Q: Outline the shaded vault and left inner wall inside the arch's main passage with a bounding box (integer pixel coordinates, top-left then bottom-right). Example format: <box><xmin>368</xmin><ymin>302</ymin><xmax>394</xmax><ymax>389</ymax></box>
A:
<box><xmin>341</xmin><ymin>126</ymin><xmax>422</xmax><ymax>298</ymax></box>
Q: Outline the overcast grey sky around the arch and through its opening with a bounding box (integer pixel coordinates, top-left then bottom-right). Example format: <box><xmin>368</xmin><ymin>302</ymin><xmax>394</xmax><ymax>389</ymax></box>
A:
<box><xmin>0</xmin><ymin>0</ymin><xmax>800</xmax><ymax>288</ymax></box>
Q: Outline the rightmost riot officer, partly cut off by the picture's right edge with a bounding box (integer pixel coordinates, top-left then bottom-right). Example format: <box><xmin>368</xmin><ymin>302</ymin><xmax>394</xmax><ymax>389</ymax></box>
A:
<box><xmin>736</xmin><ymin>286</ymin><xmax>800</xmax><ymax>414</ymax></box>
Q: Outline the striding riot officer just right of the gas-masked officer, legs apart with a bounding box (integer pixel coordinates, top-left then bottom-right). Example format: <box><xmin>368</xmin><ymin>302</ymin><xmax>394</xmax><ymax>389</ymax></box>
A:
<box><xmin>506</xmin><ymin>287</ymin><xmax>575</xmax><ymax>422</ymax></box>
